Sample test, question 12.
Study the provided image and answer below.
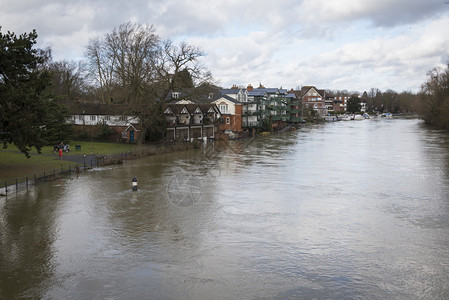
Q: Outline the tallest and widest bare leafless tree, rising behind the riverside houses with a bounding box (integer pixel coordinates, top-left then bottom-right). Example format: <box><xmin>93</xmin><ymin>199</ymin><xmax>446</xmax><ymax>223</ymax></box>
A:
<box><xmin>86</xmin><ymin>22</ymin><xmax>212</xmax><ymax>143</ymax></box>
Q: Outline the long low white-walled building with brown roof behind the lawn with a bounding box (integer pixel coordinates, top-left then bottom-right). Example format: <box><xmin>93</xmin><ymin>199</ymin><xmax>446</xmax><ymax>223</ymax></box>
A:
<box><xmin>66</xmin><ymin>103</ymin><xmax>140</xmax><ymax>143</ymax></box>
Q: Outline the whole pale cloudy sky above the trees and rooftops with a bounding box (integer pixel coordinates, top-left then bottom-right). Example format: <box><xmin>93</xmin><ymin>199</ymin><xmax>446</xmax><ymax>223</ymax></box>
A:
<box><xmin>0</xmin><ymin>0</ymin><xmax>449</xmax><ymax>92</ymax></box>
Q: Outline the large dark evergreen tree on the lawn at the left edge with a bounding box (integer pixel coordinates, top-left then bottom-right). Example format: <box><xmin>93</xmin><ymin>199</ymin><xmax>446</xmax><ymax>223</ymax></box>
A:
<box><xmin>0</xmin><ymin>28</ymin><xmax>70</xmax><ymax>157</ymax></box>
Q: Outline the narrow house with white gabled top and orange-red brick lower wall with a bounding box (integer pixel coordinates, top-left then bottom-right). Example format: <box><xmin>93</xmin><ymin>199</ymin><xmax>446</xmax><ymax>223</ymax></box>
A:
<box><xmin>212</xmin><ymin>95</ymin><xmax>242</xmax><ymax>134</ymax></box>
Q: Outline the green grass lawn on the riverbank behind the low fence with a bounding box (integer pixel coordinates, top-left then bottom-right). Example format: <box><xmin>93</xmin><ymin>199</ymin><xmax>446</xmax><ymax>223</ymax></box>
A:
<box><xmin>0</xmin><ymin>141</ymin><xmax>137</xmax><ymax>187</ymax></box>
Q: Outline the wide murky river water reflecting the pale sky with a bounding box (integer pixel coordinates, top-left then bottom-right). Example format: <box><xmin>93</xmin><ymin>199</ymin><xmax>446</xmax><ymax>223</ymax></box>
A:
<box><xmin>0</xmin><ymin>120</ymin><xmax>449</xmax><ymax>299</ymax></box>
